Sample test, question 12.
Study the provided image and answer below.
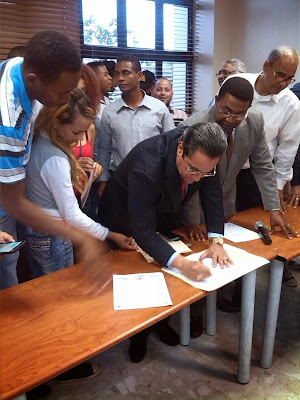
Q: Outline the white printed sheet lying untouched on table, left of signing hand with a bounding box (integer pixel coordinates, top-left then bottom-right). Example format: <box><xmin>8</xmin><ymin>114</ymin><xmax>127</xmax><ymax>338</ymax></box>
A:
<box><xmin>113</xmin><ymin>272</ymin><xmax>173</xmax><ymax>310</ymax></box>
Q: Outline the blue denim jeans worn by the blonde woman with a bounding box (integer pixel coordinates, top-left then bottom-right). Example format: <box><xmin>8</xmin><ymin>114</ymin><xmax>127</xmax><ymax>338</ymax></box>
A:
<box><xmin>18</xmin><ymin>225</ymin><xmax>74</xmax><ymax>278</ymax></box>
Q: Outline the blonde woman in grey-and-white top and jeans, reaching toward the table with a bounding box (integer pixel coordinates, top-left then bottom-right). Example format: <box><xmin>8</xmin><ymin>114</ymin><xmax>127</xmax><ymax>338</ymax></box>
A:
<box><xmin>21</xmin><ymin>89</ymin><xmax>136</xmax><ymax>278</ymax></box>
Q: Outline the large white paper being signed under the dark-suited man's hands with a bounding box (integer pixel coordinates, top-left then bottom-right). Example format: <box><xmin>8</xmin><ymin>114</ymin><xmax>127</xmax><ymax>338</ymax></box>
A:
<box><xmin>163</xmin><ymin>244</ymin><xmax>269</xmax><ymax>292</ymax></box>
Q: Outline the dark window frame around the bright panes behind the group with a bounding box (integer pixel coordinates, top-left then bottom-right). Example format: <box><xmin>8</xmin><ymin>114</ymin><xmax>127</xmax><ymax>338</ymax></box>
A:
<box><xmin>78</xmin><ymin>0</ymin><xmax>194</xmax><ymax>113</ymax></box>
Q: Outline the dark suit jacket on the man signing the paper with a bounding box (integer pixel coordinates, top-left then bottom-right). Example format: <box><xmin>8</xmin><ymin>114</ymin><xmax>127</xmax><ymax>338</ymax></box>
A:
<box><xmin>101</xmin><ymin>129</ymin><xmax>224</xmax><ymax>265</ymax></box>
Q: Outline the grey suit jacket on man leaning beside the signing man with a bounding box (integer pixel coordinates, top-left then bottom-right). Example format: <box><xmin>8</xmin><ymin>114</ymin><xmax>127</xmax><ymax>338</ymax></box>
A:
<box><xmin>180</xmin><ymin>106</ymin><xmax>280</xmax><ymax>223</ymax></box>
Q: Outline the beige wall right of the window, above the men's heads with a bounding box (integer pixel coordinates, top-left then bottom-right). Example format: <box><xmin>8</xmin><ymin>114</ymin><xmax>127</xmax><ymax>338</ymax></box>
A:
<box><xmin>195</xmin><ymin>0</ymin><xmax>300</xmax><ymax>110</ymax></box>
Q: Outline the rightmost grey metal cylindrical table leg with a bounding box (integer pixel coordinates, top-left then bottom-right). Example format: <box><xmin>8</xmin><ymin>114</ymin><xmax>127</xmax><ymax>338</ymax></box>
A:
<box><xmin>260</xmin><ymin>257</ymin><xmax>286</xmax><ymax>368</ymax></box>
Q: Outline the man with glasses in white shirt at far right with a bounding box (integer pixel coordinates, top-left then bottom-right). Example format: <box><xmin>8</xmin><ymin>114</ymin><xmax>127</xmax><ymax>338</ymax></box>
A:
<box><xmin>232</xmin><ymin>46</ymin><xmax>300</xmax><ymax>286</ymax></box>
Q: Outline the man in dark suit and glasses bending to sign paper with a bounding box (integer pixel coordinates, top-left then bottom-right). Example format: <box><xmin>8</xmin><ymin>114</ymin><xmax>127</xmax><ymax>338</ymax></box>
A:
<box><xmin>101</xmin><ymin>123</ymin><xmax>231</xmax><ymax>362</ymax></box>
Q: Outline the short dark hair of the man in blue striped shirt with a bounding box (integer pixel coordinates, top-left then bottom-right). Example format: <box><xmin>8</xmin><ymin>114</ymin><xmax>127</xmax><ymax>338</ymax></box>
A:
<box><xmin>23</xmin><ymin>31</ymin><xmax>81</xmax><ymax>82</ymax></box>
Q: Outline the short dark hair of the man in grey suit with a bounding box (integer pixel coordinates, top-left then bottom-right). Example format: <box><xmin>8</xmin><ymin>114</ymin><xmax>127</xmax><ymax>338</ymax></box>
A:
<box><xmin>218</xmin><ymin>76</ymin><xmax>254</xmax><ymax>104</ymax></box>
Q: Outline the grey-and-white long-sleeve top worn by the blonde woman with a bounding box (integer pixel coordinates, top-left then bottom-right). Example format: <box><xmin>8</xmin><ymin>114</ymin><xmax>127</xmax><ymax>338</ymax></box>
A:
<box><xmin>26</xmin><ymin>133</ymin><xmax>109</xmax><ymax>240</ymax></box>
